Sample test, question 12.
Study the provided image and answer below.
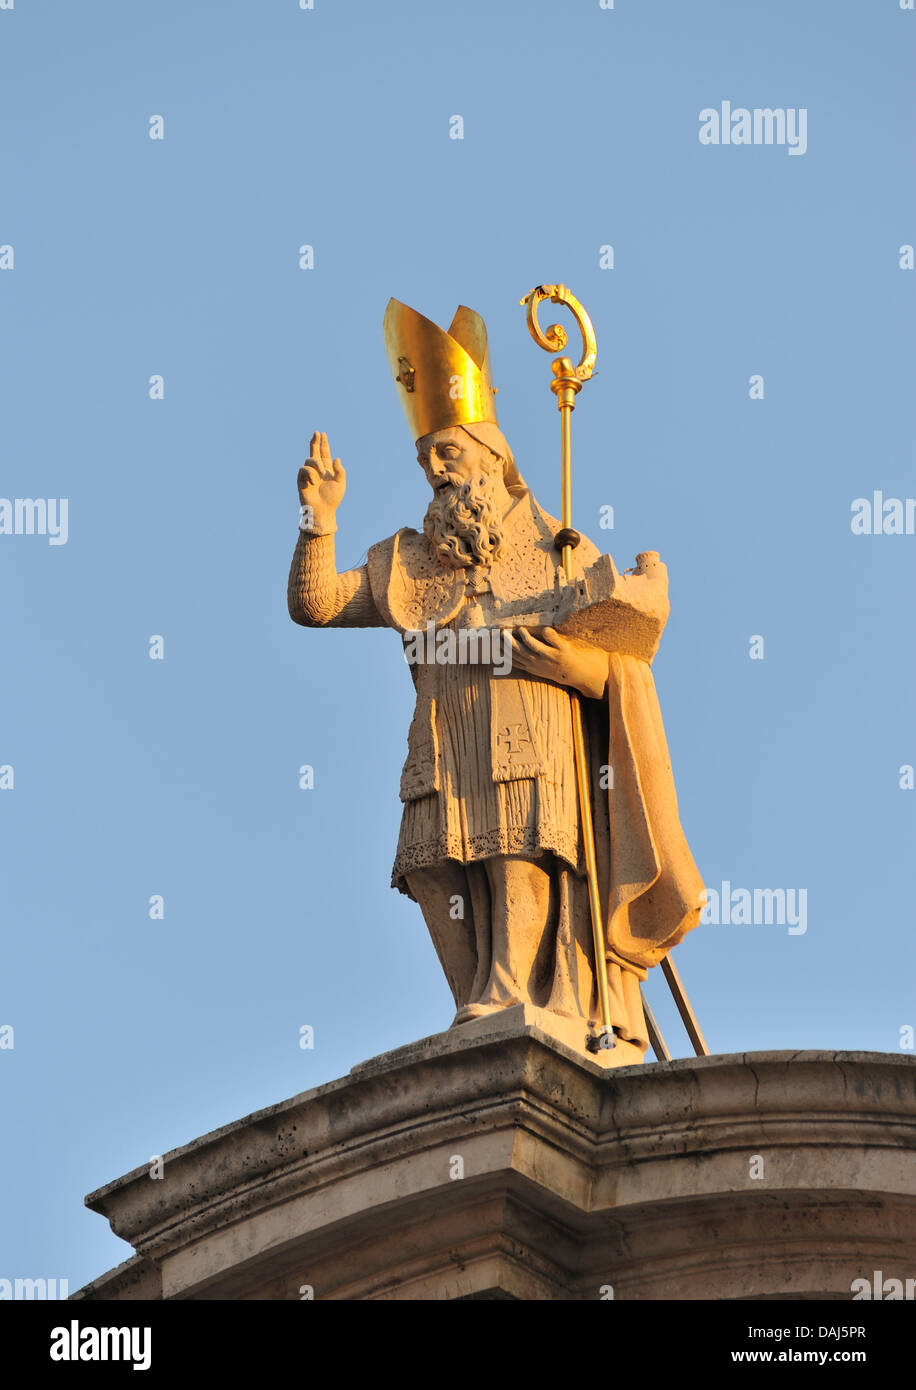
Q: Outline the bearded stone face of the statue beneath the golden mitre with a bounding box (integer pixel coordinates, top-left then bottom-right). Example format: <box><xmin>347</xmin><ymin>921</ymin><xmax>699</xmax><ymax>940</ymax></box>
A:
<box><xmin>418</xmin><ymin>428</ymin><xmax>509</xmax><ymax>569</ymax></box>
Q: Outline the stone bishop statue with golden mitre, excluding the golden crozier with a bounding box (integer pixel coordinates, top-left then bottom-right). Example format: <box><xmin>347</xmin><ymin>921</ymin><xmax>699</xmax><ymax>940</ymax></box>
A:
<box><xmin>289</xmin><ymin>299</ymin><xmax>702</xmax><ymax>1065</ymax></box>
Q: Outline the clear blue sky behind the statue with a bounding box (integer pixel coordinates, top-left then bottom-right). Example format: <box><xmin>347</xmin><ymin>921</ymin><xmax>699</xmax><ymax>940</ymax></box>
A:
<box><xmin>0</xmin><ymin>0</ymin><xmax>916</xmax><ymax>1289</ymax></box>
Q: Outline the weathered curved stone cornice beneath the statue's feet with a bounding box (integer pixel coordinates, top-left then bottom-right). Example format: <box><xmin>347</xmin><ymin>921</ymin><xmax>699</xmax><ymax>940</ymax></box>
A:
<box><xmin>74</xmin><ymin>1028</ymin><xmax>916</xmax><ymax>1301</ymax></box>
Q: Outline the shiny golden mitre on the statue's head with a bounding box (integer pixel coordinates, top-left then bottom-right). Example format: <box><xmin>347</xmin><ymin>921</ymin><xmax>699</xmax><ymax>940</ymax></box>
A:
<box><xmin>385</xmin><ymin>299</ymin><xmax>498</xmax><ymax>441</ymax></box>
